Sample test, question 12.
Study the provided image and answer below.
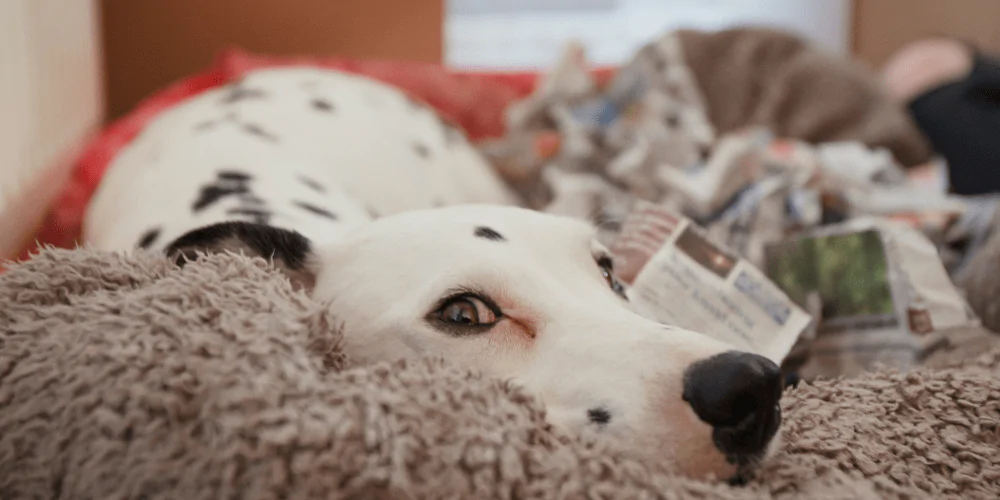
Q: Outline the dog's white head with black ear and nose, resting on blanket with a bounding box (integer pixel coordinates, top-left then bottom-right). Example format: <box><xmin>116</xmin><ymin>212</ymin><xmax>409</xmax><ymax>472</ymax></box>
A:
<box><xmin>168</xmin><ymin>205</ymin><xmax>782</xmax><ymax>478</ymax></box>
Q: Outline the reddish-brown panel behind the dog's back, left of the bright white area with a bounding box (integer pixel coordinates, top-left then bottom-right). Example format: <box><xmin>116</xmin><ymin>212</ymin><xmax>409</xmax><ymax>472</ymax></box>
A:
<box><xmin>102</xmin><ymin>0</ymin><xmax>445</xmax><ymax>118</ymax></box>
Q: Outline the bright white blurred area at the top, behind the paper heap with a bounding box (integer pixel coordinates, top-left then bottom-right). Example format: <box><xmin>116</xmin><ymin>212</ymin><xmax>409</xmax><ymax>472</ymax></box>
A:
<box><xmin>445</xmin><ymin>0</ymin><xmax>851</xmax><ymax>69</ymax></box>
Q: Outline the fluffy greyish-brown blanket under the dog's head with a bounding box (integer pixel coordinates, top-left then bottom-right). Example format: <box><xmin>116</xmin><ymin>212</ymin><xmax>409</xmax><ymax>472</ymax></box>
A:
<box><xmin>0</xmin><ymin>250</ymin><xmax>1000</xmax><ymax>499</ymax></box>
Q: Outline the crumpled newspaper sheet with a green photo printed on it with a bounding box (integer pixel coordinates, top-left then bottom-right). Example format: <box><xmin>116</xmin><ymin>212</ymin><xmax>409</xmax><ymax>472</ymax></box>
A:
<box><xmin>767</xmin><ymin>216</ymin><xmax>979</xmax><ymax>378</ymax></box>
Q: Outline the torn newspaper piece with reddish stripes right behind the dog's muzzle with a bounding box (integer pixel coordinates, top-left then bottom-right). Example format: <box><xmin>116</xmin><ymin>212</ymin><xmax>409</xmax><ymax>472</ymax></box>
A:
<box><xmin>611</xmin><ymin>201</ymin><xmax>811</xmax><ymax>364</ymax></box>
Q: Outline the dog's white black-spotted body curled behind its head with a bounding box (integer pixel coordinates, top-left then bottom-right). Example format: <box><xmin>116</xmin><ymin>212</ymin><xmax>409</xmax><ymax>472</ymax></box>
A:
<box><xmin>83</xmin><ymin>68</ymin><xmax>514</xmax><ymax>250</ymax></box>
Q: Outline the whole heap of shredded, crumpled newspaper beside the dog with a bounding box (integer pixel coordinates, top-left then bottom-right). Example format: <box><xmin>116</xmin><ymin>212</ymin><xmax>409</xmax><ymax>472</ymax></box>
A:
<box><xmin>483</xmin><ymin>33</ymin><xmax>997</xmax><ymax>375</ymax></box>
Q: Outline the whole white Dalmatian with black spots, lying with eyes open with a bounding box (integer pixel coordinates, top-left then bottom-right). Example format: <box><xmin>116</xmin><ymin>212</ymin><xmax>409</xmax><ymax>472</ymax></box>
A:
<box><xmin>84</xmin><ymin>69</ymin><xmax>782</xmax><ymax>478</ymax></box>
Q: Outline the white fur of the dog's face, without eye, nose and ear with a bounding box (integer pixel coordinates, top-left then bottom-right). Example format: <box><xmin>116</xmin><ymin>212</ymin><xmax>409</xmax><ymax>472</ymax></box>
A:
<box><xmin>313</xmin><ymin>205</ymin><xmax>733</xmax><ymax>477</ymax></box>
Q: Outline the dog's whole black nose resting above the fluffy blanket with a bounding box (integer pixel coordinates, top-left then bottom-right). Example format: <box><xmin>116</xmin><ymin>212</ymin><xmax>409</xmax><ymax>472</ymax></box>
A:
<box><xmin>684</xmin><ymin>351</ymin><xmax>784</xmax><ymax>457</ymax></box>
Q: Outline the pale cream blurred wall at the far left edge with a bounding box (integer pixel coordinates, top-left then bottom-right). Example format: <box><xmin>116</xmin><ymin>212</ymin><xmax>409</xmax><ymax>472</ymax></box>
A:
<box><xmin>0</xmin><ymin>0</ymin><xmax>103</xmax><ymax>257</ymax></box>
